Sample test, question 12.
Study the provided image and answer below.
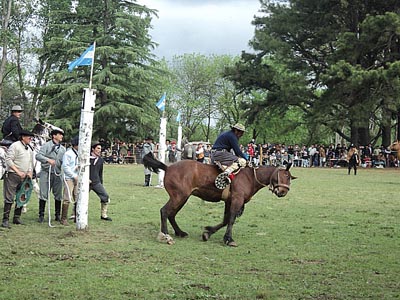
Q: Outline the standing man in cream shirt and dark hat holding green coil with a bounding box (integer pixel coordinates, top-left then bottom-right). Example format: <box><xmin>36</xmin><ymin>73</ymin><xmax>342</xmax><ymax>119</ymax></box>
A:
<box><xmin>1</xmin><ymin>130</ymin><xmax>33</xmax><ymax>228</ymax></box>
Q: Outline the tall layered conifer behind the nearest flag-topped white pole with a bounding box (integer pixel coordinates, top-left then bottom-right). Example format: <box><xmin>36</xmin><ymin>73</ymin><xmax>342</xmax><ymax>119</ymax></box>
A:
<box><xmin>33</xmin><ymin>0</ymin><xmax>159</xmax><ymax>140</ymax></box>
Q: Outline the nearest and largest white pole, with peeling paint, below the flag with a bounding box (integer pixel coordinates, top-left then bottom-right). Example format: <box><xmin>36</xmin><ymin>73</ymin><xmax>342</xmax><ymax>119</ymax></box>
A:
<box><xmin>76</xmin><ymin>88</ymin><xmax>96</xmax><ymax>230</ymax></box>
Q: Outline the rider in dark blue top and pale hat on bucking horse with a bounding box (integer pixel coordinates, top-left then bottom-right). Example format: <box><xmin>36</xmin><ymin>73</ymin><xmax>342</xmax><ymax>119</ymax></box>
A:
<box><xmin>211</xmin><ymin>123</ymin><xmax>247</xmax><ymax>182</ymax></box>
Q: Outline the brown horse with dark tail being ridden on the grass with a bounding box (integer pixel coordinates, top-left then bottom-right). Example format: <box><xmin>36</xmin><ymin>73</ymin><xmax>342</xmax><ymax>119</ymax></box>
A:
<box><xmin>143</xmin><ymin>153</ymin><xmax>296</xmax><ymax>246</ymax></box>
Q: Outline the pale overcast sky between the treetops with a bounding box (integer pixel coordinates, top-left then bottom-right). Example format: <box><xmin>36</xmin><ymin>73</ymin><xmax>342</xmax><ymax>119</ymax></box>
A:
<box><xmin>137</xmin><ymin>0</ymin><xmax>260</xmax><ymax>59</ymax></box>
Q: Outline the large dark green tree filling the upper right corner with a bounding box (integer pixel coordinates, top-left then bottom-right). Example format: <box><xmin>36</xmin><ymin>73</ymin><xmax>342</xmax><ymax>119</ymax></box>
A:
<box><xmin>230</xmin><ymin>0</ymin><xmax>400</xmax><ymax>145</ymax></box>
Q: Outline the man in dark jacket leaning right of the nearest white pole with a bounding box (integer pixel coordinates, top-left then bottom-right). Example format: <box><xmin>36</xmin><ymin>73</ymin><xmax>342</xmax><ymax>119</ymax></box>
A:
<box><xmin>89</xmin><ymin>142</ymin><xmax>112</xmax><ymax>221</ymax></box>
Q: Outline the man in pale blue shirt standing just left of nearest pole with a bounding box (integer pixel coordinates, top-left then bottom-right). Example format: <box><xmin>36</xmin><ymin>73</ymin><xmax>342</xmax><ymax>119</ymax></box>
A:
<box><xmin>60</xmin><ymin>136</ymin><xmax>79</xmax><ymax>226</ymax></box>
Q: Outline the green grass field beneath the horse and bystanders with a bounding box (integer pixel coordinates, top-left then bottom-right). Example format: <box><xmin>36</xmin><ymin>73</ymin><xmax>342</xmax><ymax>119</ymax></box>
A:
<box><xmin>0</xmin><ymin>165</ymin><xmax>400</xmax><ymax>300</ymax></box>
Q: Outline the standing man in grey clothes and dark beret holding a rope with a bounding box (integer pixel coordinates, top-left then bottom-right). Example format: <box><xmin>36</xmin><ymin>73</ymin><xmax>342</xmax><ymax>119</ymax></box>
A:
<box><xmin>36</xmin><ymin>129</ymin><xmax>65</xmax><ymax>223</ymax></box>
